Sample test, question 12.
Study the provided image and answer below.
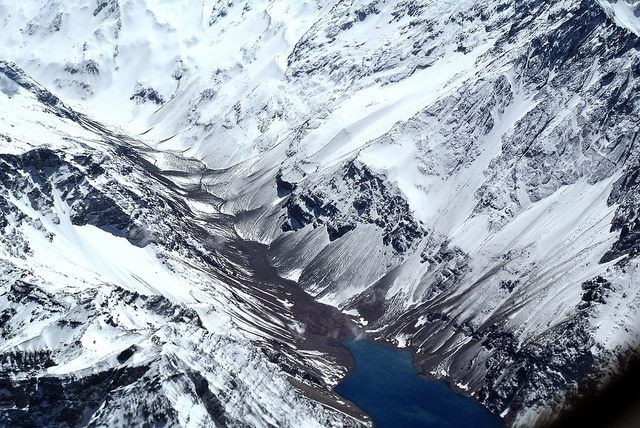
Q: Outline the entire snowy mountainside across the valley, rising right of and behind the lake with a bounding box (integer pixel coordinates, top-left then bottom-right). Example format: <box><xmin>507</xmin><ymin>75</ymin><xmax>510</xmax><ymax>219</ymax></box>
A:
<box><xmin>0</xmin><ymin>0</ymin><xmax>640</xmax><ymax>424</ymax></box>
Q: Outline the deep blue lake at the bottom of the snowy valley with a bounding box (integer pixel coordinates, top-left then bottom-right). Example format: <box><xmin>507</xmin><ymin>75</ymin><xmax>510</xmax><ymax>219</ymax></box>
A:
<box><xmin>335</xmin><ymin>340</ymin><xmax>502</xmax><ymax>428</ymax></box>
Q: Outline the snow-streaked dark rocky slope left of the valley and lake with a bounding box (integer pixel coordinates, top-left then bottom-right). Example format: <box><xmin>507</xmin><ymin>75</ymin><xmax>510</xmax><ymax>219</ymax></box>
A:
<box><xmin>0</xmin><ymin>63</ymin><xmax>363</xmax><ymax>427</ymax></box>
